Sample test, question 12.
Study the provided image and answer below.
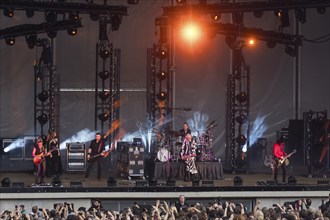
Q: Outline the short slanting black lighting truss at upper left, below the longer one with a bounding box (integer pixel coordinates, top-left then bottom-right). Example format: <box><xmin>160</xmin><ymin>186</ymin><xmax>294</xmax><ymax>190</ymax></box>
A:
<box><xmin>0</xmin><ymin>19</ymin><xmax>82</xmax><ymax>39</ymax></box>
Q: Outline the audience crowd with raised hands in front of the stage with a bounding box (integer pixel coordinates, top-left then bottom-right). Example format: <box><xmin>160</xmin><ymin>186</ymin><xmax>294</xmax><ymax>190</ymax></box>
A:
<box><xmin>0</xmin><ymin>194</ymin><xmax>330</xmax><ymax>220</ymax></box>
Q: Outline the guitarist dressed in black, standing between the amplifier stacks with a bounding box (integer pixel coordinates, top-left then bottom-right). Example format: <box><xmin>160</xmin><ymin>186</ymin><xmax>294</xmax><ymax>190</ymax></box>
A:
<box><xmin>85</xmin><ymin>132</ymin><xmax>108</xmax><ymax>180</ymax></box>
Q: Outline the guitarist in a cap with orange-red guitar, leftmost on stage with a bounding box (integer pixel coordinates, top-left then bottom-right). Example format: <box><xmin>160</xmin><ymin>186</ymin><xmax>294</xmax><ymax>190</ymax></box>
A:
<box><xmin>32</xmin><ymin>138</ymin><xmax>48</xmax><ymax>184</ymax></box>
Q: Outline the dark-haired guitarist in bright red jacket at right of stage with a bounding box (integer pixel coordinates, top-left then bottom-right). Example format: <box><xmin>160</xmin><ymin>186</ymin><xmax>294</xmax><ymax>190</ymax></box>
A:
<box><xmin>273</xmin><ymin>137</ymin><xmax>287</xmax><ymax>182</ymax></box>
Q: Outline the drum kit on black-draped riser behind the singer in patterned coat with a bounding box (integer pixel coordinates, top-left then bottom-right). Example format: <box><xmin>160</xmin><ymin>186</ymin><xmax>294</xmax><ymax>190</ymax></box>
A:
<box><xmin>154</xmin><ymin>121</ymin><xmax>217</xmax><ymax>162</ymax></box>
